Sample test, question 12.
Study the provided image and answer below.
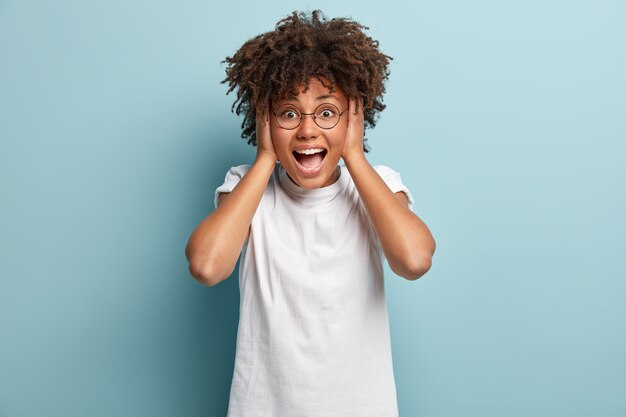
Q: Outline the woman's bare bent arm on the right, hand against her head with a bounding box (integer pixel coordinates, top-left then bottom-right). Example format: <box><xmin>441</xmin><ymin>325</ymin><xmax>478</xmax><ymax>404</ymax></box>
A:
<box><xmin>342</xmin><ymin>100</ymin><xmax>435</xmax><ymax>280</ymax></box>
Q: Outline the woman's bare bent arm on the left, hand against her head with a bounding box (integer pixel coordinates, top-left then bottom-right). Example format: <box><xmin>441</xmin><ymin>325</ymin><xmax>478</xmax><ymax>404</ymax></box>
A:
<box><xmin>185</xmin><ymin>113</ymin><xmax>276</xmax><ymax>286</ymax></box>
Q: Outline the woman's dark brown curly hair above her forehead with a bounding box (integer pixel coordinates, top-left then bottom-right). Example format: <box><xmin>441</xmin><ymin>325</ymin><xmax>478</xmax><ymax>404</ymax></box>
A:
<box><xmin>221</xmin><ymin>10</ymin><xmax>392</xmax><ymax>152</ymax></box>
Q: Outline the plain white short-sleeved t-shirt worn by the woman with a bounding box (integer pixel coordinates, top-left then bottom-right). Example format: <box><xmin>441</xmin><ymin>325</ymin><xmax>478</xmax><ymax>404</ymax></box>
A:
<box><xmin>215</xmin><ymin>163</ymin><xmax>413</xmax><ymax>417</ymax></box>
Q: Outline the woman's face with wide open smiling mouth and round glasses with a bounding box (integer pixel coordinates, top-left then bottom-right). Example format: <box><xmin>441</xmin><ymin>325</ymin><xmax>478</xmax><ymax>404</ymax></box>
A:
<box><xmin>270</xmin><ymin>78</ymin><xmax>348</xmax><ymax>188</ymax></box>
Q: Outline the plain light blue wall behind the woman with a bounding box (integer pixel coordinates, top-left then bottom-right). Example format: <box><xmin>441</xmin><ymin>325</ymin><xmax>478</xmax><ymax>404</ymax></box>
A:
<box><xmin>0</xmin><ymin>0</ymin><xmax>626</xmax><ymax>417</ymax></box>
